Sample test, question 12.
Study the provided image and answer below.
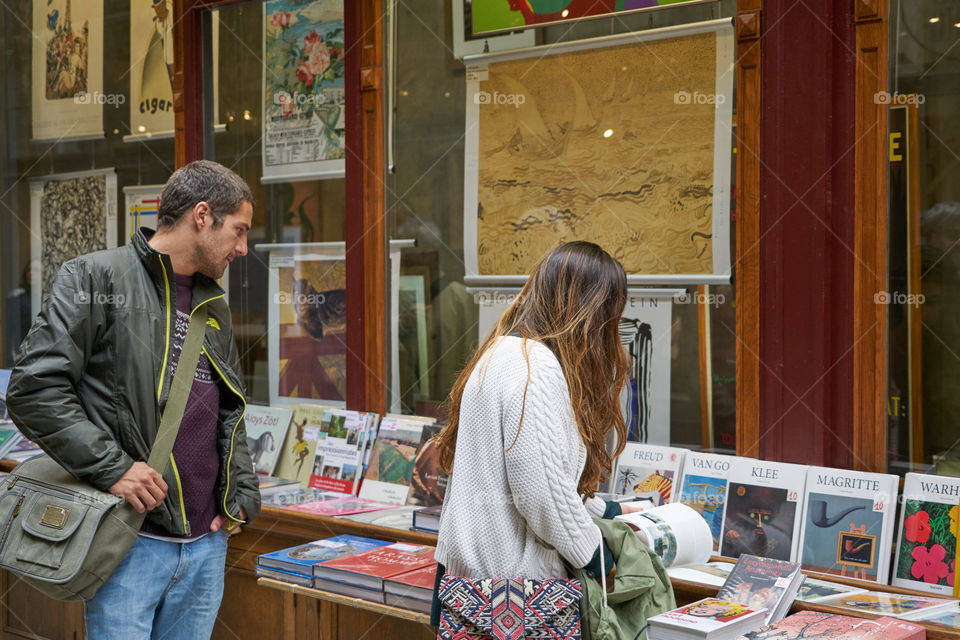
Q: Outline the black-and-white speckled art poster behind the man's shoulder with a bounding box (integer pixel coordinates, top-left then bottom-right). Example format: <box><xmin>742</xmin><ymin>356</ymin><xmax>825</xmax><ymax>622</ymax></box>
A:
<box><xmin>30</xmin><ymin>169</ymin><xmax>117</xmax><ymax>315</ymax></box>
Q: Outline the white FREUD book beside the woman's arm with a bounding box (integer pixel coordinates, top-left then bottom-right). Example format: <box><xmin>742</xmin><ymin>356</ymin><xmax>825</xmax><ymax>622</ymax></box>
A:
<box><xmin>613</xmin><ymin>442</ymin><xmax>687</xmax><ymax>506</ymax></box>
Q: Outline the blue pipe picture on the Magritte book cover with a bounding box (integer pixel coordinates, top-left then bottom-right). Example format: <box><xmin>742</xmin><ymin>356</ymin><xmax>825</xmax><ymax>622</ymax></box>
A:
<box><xmin>802</xmin><ymin>493</ymin><xmax>886</xmax><ymax>581</ymax></box>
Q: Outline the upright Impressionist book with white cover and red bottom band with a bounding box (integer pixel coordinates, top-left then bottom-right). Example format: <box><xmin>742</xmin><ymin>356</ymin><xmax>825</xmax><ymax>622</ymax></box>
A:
<box><xmin>307</xmin><ymin>409</ymin><xmax>369</xmax><ymax>495</ymax></box>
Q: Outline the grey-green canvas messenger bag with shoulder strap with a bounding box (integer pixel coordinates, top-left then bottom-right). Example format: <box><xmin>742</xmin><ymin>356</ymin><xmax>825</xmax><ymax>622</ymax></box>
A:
<box><xmin>0</xmin><ymin>306</ymin><xmax>207</xmax><ymax>600</ymax></box>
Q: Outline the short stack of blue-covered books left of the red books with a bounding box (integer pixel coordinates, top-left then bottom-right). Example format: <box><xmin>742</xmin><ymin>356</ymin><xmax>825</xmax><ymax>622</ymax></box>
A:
<box><xmin>256</xmin><ymin>534</ymin><xmax>390</xmax><ymax>587</ymax></box>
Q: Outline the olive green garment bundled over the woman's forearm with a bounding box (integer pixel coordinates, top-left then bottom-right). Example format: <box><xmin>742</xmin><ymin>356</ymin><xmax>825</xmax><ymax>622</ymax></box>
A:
<box><xmin>574</xmin><ymin>519</ymin><xmax>677</xmax><ymax>640</ymax></box>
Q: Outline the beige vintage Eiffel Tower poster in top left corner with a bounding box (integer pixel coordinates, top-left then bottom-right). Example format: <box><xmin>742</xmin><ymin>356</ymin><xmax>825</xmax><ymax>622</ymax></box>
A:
<box><xmin>31</xmin><ymin>0</ymin><xmax>104</xmax><ymax>141</ymax></box>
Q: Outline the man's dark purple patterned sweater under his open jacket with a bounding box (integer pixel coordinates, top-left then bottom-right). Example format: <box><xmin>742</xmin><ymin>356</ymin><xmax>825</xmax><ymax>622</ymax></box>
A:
<box><xmin>141</xmin><ymin>273</ymin><xmax>220</xmax><ymax>538</ymax></box>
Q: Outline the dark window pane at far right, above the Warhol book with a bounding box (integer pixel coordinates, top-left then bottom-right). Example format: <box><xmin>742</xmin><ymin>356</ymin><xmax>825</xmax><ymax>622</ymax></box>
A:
<box><xmin>876</xmin><ymin>0</ymin><xmax>960</xmax><ymax>475</ymax></box>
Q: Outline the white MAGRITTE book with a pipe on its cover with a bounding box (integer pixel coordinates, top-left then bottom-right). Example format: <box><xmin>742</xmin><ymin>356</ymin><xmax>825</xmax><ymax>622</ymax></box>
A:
<box><xmin>798</xmin><ymin>467</ymin><xmax>900</xmax><ymax>584</ymax></box>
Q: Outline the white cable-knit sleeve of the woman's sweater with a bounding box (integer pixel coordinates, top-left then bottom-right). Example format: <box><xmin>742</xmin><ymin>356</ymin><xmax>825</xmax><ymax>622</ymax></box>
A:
<box><xmin>503</xmin><ymin>354</ymin><xmax>601</xmax><ymax>567</ymax></box>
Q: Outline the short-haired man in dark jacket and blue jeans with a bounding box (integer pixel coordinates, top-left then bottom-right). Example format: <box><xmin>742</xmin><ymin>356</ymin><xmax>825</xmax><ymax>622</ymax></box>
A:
<box><xmin>8</xmin><ymin>161</ymin><xmax>260</xmax><ymax>640</ymax></box>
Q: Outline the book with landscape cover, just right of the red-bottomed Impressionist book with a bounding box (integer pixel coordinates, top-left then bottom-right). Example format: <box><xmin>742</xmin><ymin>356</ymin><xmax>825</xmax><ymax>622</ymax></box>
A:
<box><xmin>360</xmin><ymin>418</ymin><xmax>426</xmax><ymax>505</ymax></box>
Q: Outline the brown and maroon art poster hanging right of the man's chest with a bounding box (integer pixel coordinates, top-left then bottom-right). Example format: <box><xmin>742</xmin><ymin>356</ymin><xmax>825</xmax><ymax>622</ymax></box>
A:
<box><xmin>268</xmin><ymin>248</ymin><xmax>347</xmax><ymax>407</ymax></box>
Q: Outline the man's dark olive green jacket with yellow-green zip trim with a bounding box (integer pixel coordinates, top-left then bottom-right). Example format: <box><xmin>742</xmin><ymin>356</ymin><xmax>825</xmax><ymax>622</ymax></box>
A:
<box><xmin>7</xmin><ymin>231</ymin><xmax>260</xmax><ymax>536</ymax></box>
